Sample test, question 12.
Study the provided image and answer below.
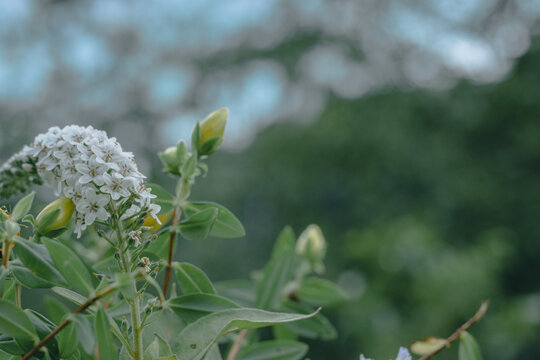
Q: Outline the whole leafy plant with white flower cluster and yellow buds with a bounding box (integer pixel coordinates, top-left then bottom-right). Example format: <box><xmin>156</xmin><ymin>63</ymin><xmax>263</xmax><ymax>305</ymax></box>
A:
<box><xmin>0</xmin><ymin>109</ymin><xmax>346</xmax><ymax>360</ymax></box>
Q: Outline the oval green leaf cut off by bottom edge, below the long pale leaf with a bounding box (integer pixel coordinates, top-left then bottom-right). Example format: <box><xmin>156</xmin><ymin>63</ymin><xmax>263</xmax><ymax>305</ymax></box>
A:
<box><xmin>236</xmin><ymin>340</ymin><xmax>308</xmax><ymax>360</ymax></box>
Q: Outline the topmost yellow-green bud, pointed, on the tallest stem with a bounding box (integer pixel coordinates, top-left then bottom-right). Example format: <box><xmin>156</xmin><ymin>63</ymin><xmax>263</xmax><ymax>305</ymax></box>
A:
<box><xmin>197</xmin><ymin>108</ymin><xmax>229</xmax><ymax>155</ymax></box>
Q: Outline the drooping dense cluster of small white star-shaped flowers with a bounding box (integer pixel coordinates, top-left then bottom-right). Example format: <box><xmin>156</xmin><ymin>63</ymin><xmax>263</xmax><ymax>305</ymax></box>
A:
<box><xmin>6</xmin><ymin>125</ymin><xmax>160</xmax><ymax>237</ymax></box>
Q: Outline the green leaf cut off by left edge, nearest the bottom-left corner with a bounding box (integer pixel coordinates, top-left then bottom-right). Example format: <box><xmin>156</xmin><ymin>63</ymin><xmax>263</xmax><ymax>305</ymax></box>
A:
<box><xmin>0</xmin><ymin>300</ymin><xmax>39</xmax><ymax>350</ymax></box>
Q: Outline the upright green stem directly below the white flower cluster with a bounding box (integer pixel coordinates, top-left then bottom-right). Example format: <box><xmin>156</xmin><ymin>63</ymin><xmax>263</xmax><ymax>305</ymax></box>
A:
<box><xmin>115</xmin><ymin>220</ymin><xmax>144</xmax><ymax>360</ymax></box>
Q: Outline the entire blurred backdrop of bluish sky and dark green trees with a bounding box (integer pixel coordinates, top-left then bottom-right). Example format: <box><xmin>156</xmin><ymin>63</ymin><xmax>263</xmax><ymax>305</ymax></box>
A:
<box><xmin>0</xmin><ymin>0</ymin><xmax>540</xmax><ymax>360</ymax></box>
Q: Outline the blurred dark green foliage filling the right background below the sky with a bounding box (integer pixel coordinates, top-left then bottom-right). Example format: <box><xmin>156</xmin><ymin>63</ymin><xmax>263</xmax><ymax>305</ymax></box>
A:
<box><xmin>180</xmin><ymin>44</ymin><xmax>540</xmax><ymax>360</ymax></box>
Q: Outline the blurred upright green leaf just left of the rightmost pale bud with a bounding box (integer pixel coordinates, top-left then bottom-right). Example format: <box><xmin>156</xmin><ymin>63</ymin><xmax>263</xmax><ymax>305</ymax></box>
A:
<box><xmin>257</xmin><ymin>227</ymin><xmax>296</xmax><ymax>309</ymax></box>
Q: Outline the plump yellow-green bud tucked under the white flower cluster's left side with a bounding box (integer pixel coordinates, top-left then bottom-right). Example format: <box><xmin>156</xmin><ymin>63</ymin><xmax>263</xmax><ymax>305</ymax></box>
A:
<box><xmin>36</xmin><ymin>197</ymin><xmax>75</xmax><ymax>236</ymax></box>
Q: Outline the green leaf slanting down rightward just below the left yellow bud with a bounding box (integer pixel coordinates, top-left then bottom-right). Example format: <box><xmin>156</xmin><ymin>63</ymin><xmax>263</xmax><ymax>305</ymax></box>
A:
<box><xmin>42</xmin><ymin>238</ymin><xmax>94</xmax><ymax>296</ymax></box>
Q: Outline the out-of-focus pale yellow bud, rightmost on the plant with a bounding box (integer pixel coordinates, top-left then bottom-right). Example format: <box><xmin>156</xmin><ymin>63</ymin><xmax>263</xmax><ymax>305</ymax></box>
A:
<box><xmin>296</xmin><ymin>224</ymin><xmax>326</xmax><ymax>273</ymax></box>
